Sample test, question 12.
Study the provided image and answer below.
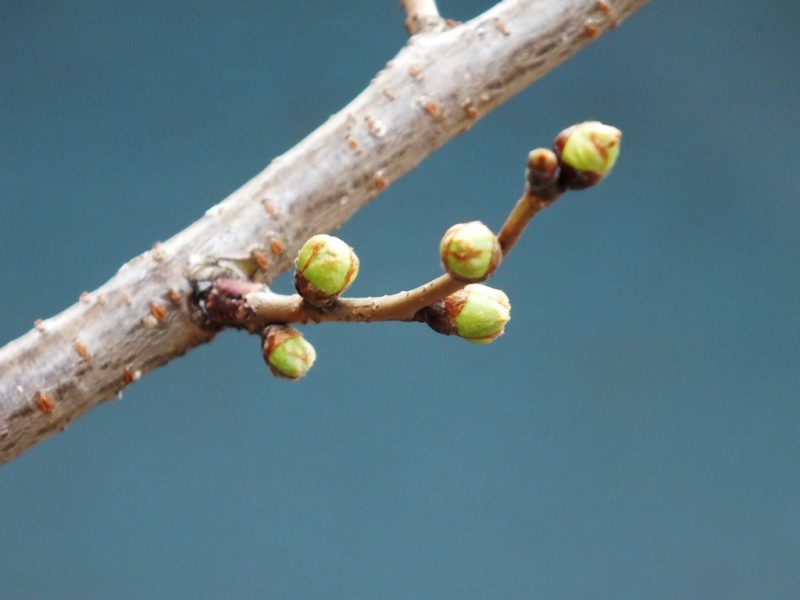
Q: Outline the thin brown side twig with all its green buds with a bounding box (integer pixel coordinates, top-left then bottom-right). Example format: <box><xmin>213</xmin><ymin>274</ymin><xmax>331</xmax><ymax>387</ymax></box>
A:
<box><xmin>197</xmin><ymin>121</ymin><xmax>621</xmax><ymax>379</ymax></box>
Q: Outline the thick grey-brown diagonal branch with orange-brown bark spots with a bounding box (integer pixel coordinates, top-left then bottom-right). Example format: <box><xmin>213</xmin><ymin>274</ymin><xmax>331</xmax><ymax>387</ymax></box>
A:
<box><xmin>0</xmin><ymin>0</ymin><xmax>647</xmax><ymax>463</ymax></box>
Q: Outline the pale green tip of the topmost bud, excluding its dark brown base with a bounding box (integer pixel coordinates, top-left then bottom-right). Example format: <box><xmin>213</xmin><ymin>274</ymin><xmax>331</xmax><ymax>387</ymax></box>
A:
<box><xmin>559</xmin><ymin>121</ymin><xmax>622</xmax><ymax>176</ymax></box>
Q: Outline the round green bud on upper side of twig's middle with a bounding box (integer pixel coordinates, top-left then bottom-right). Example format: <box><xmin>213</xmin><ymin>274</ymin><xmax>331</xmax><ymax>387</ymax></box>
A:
<box><xmin>439</xmin><ymin>221</ymin><xmax>503</xmax><ymax>281</ymax></box>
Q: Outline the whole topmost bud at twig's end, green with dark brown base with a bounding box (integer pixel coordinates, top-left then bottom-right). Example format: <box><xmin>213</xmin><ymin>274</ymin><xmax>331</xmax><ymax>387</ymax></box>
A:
<box><xmin>553</xmin><ymin>121</ymin><xmax>622</xmax><ymax>189</ymax></box>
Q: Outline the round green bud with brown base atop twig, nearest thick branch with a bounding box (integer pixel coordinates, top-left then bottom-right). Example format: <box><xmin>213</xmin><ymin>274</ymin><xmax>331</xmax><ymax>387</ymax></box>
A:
<box><xmin>294</xmin><ymin>234</ymin><xmax>359</xmax><ymax>306</ymax></box>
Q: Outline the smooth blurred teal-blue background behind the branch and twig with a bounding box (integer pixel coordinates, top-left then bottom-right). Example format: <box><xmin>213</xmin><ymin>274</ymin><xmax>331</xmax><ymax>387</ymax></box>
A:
<box><xmin>0</xmin><ymin>0</ymin><xmax>800</xmax><ymax>600</ymax></box>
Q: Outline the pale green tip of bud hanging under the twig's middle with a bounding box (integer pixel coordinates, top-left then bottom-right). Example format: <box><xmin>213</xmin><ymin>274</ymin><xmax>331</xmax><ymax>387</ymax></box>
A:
<box><xmin>445</xmin><ymin>283</ymin><xmax>511</xmax><ymax>344</ymax></box>
